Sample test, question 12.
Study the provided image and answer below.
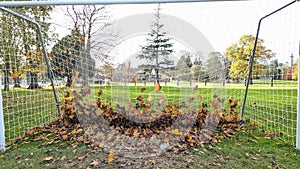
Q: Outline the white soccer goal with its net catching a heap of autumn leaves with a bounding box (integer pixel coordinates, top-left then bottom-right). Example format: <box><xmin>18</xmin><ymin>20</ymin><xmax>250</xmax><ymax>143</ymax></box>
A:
<box><xmin>0</xmin><ymin>0</ymin><xmax>300</xmax><ymax>153</ymax></box>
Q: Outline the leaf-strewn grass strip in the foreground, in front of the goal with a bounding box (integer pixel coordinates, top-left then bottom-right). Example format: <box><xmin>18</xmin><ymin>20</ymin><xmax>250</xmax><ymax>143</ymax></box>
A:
<box><xmin>0</xmin><ymin>123</ymin><xmax>300</xmax><ymax>169</ymax></box>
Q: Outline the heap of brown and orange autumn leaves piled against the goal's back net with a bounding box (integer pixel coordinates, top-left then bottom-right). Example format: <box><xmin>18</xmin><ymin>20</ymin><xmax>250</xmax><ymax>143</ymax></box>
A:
<box><xmin>15</xmin><ymin>86</ymin><xmax>243</xmax><ymax>162</ymax></box>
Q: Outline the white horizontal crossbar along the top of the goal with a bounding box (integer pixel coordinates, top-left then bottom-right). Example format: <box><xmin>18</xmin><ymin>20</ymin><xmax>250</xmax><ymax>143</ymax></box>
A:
<box><xmin>0</xmin><ymin>0</ymin><xmax>248</xmax><ymax>7</ymax></box>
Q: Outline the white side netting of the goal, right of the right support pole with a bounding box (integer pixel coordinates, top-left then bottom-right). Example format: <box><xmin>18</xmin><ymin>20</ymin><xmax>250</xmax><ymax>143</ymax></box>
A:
<box><xmin>246</xmin><ymin>1</ymin><xmax>299</xmax><ymax>145</ymax></box>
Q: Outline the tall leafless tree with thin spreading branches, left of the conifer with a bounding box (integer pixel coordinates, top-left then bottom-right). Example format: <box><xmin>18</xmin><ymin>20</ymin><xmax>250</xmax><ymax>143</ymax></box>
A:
<box><xmin>67</xmin><ymin>5</ymin><xmax>118</xmax><ymax>85</ymax></box>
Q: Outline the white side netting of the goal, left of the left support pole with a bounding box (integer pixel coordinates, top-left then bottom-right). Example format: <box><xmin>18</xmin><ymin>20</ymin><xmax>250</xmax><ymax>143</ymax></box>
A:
<box><xmin>0</xmin><ymin>8</ymin><xmax>58</xmax><ymax>145</ymax></box>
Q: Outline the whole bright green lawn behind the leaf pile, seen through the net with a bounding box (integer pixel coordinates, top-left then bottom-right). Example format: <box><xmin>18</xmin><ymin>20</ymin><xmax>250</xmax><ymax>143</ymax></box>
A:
<box><xmin>3</xmin><ymin>81</ymin><xmax>297</xmax><ymax>145</ymax></box>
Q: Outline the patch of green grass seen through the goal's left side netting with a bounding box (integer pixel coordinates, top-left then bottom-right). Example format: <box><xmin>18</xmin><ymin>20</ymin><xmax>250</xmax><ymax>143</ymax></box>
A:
<box><xmin>2</xmin><ymin>88</ymin><xmax>57</xmax><ymax>144</ymax></box>
